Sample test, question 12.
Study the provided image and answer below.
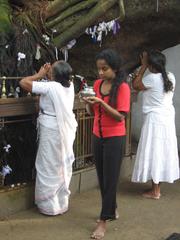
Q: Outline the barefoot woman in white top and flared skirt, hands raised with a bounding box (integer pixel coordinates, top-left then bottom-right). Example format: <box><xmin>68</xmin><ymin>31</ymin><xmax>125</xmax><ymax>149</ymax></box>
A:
<box><xmin>132</xmin><ymin>50</ymin><xmax>180</xmax><ymax>199</ymax></box>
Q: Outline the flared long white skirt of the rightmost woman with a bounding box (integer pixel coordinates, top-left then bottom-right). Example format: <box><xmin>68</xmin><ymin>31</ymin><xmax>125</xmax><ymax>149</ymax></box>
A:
<box><xmin>132</xmin><ymin>109</ymin><xmax>180</xmax><ymax>184</ymax></box>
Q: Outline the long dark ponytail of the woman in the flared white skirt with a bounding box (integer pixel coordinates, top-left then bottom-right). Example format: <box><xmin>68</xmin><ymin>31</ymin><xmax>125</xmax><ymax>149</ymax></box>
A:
<box><xmin>147</xmin><ymin>50</ymin><xmax>173</xmax><ymax>92</ymax></box>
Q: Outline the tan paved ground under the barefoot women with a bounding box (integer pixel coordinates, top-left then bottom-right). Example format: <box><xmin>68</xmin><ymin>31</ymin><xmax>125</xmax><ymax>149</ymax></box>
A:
<box><xmin>0</xmin><ymin>182</ymin><xmax>180</xmax><ymax>240</ymax></box>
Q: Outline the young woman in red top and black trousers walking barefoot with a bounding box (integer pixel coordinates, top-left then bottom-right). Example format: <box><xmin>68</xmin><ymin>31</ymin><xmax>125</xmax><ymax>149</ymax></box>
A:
<box><xmin>84</xmin><ymin>49</ymin><xmax>130</xmax><ymax>239</ymax></box>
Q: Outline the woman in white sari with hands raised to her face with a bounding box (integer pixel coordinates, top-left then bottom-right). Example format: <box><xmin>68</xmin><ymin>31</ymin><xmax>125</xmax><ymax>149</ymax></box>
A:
<box><xmin>20</xmin><ymin>61</ymin><xmax>77</xmax><ymax>215</ymax></box>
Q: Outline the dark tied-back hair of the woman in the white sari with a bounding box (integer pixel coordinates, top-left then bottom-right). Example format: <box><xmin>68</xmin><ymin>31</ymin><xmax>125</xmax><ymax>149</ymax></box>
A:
<box><xmin>52</xmin><ymin>61</ymin><xmax>72</xmax><ymax>87</ymax></box>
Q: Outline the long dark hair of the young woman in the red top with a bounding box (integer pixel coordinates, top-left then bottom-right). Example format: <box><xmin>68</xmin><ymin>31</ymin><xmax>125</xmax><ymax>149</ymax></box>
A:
<box><xmin>96</xmin><ymin>49</ymin><xmax>125</xmax><ymax>106</ymax></box>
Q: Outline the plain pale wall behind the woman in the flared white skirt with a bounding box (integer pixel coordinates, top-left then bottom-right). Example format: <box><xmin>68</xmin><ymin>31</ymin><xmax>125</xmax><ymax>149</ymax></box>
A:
<box><xmin>132</xmin><ymin>44</ymin><xmax>180</xmax><ymax>149</ymax></box>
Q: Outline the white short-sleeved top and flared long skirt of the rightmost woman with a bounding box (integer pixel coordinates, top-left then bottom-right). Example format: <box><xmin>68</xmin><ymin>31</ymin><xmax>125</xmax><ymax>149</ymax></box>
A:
<box><xmin>132</xmin><ymin>73</ymin><xmax>180</xmax><ymax>184</ymax></box>
